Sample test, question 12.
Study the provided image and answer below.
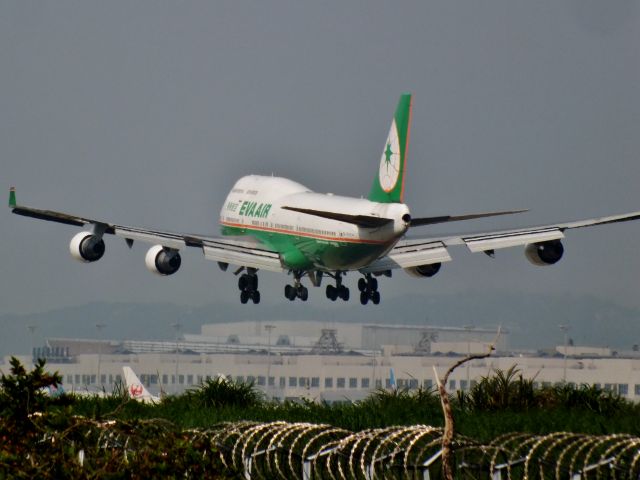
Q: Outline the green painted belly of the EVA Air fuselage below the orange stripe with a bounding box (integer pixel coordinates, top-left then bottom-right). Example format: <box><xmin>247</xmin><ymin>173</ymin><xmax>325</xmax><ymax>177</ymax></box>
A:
<box><xmin>222</xmin><ymin>225</ymin><xmax>388</xmax><ymax>270</ymax></box>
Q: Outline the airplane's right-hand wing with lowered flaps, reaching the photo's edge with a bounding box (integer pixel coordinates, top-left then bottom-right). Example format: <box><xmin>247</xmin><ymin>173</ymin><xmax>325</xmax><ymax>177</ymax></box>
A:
<box><xmin>360</xmin><ymin>211</ymin><xmax>640</xmax><ymax>273</ymax></box>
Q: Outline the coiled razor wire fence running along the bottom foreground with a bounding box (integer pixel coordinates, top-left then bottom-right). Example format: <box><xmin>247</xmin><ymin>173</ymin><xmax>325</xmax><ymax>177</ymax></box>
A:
<box><xmin>5</xmin><ymin>417</ymin><xmax>640</xmax><ymax>480</ymax></box>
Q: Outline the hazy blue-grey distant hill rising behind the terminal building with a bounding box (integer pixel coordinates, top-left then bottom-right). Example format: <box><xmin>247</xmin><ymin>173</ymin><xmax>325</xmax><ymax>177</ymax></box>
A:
<box><xmin>0</xmin><ymin>293</ymin><xmax>640</xmax><ymax>356</ymax></box>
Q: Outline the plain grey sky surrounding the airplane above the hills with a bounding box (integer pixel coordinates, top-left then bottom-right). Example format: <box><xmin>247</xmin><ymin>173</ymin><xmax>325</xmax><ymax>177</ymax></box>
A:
<box><xmin>0</xmin><ymin>0</ymin><xmax>640</xmax><ymax>315</ymax></box>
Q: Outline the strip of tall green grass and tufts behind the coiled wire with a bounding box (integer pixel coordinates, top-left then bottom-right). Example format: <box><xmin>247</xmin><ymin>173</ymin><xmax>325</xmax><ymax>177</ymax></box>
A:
<box><xmin>50</xmin><ymin>367</ymin><xmax>640</xmax><ymax>442</ymax></box>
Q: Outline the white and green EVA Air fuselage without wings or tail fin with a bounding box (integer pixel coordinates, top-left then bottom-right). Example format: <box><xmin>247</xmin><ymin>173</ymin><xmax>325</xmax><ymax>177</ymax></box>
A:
<box><xmin>220</xmin><ymin>175</ymin><xmax>409</xmax><ymax>270</ymax></box>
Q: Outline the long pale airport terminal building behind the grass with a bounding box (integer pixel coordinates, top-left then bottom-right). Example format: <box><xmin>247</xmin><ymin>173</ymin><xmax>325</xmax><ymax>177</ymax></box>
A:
<box><xmin>5</xmin><ymin>321</ymin><xmax>640</xmax><ymax>402</ymax></box>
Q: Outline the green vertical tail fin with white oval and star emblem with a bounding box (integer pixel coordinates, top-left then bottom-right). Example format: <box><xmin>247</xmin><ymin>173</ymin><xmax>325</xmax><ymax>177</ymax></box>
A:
<box><xmin>369</xmin><ymin>93</ymin><xmax>411</xmax><ymax>203</ymax></box>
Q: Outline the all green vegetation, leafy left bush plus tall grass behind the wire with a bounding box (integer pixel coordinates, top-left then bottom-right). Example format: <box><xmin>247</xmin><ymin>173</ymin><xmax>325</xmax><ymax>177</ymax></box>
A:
<box><xmin>0</xmin><ymin>359</ymin><xmax>640</xmax><ymax>479</ymax></box>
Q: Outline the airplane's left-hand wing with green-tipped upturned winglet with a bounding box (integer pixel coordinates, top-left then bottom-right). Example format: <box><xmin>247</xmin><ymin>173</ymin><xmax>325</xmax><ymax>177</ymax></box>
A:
<box><xmin>9</xmin><ymin>190</ymin><xmax>285</xmax><ymax>272</ymax></box>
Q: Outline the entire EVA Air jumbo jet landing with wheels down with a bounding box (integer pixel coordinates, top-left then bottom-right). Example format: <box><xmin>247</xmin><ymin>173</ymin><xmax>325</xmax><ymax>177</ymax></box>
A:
<box><xmin>9</xmin><ymin>94</ymin><xmax>640</xmax><ymax>305</ymax></box>
